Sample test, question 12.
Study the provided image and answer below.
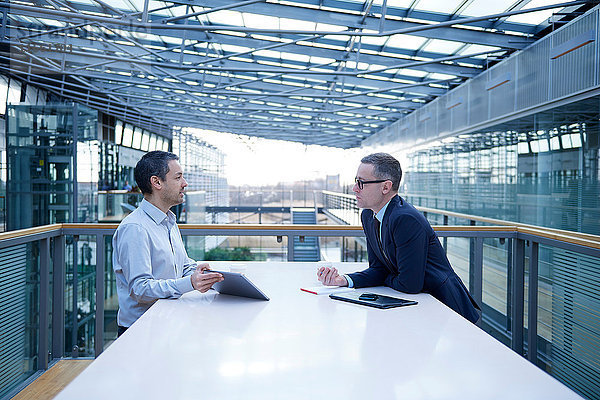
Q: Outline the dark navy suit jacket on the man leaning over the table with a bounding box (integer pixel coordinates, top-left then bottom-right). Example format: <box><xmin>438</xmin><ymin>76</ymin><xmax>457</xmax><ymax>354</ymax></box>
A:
<box><xmin>349</xmin><ymin>196</ymin><xmax>479</xmax><ymax>323</ymax></box>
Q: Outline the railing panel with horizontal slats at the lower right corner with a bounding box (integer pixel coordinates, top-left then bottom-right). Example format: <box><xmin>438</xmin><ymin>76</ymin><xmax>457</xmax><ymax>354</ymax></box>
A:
<box><xmin>537</xmin><ymin>245</ymin><xmax>600</xmax><ymax>398</ymax></box>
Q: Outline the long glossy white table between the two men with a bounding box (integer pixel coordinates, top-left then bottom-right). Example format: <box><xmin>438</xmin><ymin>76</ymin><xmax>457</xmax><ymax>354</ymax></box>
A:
<box><xmin>57</xmin><ymin>262</ymin><xmax>581</xmax><ymax>400</ymax></box>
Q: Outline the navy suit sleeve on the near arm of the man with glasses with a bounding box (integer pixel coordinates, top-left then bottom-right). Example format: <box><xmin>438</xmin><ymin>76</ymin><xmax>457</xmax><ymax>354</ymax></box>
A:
<box><xmin>385</xmin><ymin>215</ymin><xmax>428</xmax><ymax>293</ymax></box>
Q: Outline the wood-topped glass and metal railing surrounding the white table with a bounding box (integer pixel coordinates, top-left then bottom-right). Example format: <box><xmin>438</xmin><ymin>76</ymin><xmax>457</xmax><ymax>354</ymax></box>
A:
<box><xmin>0</xmin><ymin>222</ymin><xmax>600</xmax><ymax>398</ymax></box>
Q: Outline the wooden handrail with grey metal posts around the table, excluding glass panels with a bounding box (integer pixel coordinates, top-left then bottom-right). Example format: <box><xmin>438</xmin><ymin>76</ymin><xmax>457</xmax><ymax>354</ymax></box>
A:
<box><xmin>0</xmin><ymin>223</ymin><xmax>600</xmax><ymax>400</ymax></box>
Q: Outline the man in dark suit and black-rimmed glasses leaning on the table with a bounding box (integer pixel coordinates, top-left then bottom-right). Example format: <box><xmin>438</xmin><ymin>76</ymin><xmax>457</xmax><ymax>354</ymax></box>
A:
<box><xmin>317</xmin><ymin>153</ymin><xmax>479</xmax><ymax>323</ymax></box>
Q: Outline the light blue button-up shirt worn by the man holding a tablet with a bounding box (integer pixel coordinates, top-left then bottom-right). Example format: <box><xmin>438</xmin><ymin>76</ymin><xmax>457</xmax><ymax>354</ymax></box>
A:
<box><xmin>112</xmin><ymin>199</ymin><xmax>196</xmax><ymax>328</ymax></box>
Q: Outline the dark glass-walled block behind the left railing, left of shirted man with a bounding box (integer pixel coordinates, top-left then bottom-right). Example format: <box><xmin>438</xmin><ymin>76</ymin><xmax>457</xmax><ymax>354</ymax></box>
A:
<box><xmin>6</xmin><ymin>104</ymin><xmax>98</xmax><ymax>230</ymax></box>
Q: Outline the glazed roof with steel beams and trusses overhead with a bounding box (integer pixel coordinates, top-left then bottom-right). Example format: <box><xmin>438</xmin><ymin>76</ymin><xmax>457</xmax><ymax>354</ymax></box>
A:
<box><xmin>7</xmin><ymin>0</ymin><xmax>570</xmax><ymax>147</ymax></box>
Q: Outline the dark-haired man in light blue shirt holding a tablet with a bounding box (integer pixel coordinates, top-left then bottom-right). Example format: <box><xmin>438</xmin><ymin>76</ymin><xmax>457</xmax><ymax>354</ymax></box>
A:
<box><xmin>113</xmin><ymin>151</ymin><xmax>223</xmax><ymax>335</ymax></box>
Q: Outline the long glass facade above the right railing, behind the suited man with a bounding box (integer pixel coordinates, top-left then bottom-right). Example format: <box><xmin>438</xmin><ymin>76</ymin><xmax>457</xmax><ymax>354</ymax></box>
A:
<box><xmin>401</xmin><ymin>97</ymin><xmax>600</xmax><ymax>235</ymax></box>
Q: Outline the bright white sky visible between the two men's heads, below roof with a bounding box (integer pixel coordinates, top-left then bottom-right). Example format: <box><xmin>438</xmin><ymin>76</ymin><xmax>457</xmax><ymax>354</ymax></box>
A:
<box><xmin>188</xmin><ymin>129</ymin><xmax>366</xmax><ymax>186</ymax></box>
